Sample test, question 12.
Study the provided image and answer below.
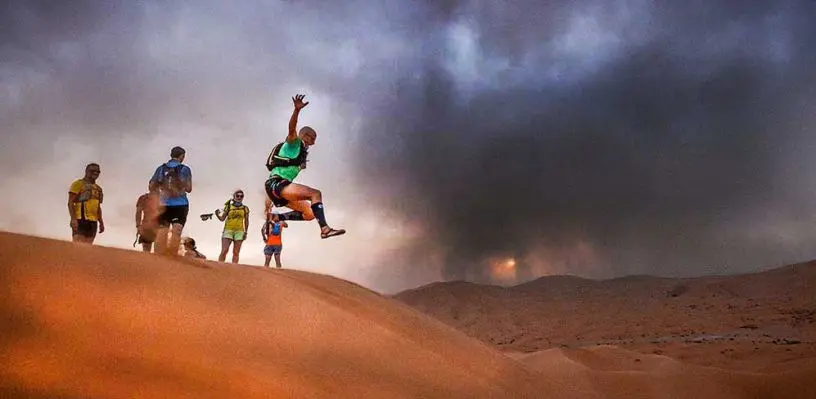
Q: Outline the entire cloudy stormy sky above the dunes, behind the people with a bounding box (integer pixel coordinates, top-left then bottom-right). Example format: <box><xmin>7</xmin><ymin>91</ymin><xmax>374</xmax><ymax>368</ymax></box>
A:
<box><xmin>0</xmin><ymin>0</ymin><xmax>816</xmax><ymax>292</ymax></box>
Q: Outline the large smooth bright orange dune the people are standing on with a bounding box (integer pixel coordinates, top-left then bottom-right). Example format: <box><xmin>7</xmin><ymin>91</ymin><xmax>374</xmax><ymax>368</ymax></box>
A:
<box><xmin>0</xmin><ymin>233</ymin><xmax>603</xmax><ymax>399</ymax></box>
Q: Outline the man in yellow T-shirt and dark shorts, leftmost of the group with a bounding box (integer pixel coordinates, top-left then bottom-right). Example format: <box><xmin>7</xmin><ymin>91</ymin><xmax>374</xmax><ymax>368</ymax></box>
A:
<box><xmin>68</xmin><ymin>163</ymin><xmax>105</xmax><ymax>244</ymax></box>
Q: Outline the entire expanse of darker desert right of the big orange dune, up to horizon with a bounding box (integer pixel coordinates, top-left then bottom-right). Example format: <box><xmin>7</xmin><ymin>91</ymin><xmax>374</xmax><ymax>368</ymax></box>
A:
<box><xmin>394</xmin><ymin>262</ymin><xmax>816</xmax><ymax>398</ymax></box>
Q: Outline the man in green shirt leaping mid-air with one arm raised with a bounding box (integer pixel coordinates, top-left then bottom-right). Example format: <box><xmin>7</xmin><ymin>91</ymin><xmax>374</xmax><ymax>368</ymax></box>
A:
<box><xmin>264</xmin><ymin>94</ymin><xmax>346</xmax><ymax>238</ymax></box>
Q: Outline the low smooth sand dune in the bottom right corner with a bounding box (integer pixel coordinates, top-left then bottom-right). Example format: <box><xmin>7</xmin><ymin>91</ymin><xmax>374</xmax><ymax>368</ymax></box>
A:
<box><xmin>513</xmin><ymin>345</ymin><xmax>816</xmax><ymax>399</ymax></box>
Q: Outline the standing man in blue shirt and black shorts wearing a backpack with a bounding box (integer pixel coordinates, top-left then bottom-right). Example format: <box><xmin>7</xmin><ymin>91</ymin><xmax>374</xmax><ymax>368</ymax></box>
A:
<box><xmin>149</xmin><ymin>147</ymin><xmax>193</xmax><ymax>255</ymax></box>
